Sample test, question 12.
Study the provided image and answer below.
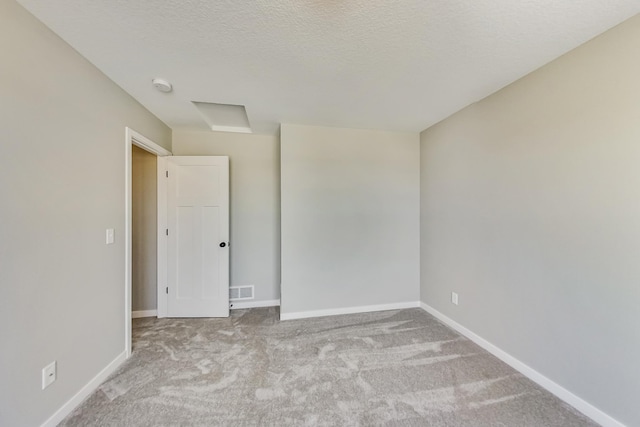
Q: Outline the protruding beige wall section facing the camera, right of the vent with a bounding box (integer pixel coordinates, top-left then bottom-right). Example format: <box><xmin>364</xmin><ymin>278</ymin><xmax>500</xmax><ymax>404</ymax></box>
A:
<box><xmin>281</xmin><ymin>124</ymin><xmax>420</xmax><ymax>315</ymax></box>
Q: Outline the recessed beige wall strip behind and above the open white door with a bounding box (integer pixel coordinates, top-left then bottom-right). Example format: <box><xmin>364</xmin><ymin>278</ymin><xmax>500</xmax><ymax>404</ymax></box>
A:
<box><xmin>173</xmin><ymin>131</ymin><xmax>280</xmax><ymax>302</ymax></box>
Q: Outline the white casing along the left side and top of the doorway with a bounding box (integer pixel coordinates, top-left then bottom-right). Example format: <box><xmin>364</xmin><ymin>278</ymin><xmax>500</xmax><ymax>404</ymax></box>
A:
<box><xmin>124</xmin><ymin>127</ymin><xmax>171</xmax><ymax>358</ymax></box>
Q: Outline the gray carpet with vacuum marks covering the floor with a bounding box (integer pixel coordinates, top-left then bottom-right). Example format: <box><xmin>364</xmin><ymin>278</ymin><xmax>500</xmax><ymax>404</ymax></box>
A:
<box><xmin>61</xmin><ymin>308</ymin><xmax>596</xmax><ymax>427</ymax></box>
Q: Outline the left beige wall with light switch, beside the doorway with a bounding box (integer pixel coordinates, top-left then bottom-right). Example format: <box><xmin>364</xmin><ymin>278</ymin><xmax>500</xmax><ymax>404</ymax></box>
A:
<box><xmin>0</xmin><ymin>0</ymin><xmax>171</xmax><ymax>427</ymax></box>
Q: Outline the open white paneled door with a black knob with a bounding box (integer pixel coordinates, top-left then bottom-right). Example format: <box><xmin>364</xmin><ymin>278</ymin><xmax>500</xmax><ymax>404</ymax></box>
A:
<box><xmin>166</xmin><ymin>156</ymin><xmax>229</xmax><ymax>317</ymax></box>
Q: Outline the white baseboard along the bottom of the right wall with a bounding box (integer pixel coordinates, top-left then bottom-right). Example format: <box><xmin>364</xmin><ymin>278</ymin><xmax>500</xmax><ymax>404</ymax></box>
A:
<box><xmin>420</xmin><ymin>302</ymin><xmax>625</xmax><ymax>427</ymax></box>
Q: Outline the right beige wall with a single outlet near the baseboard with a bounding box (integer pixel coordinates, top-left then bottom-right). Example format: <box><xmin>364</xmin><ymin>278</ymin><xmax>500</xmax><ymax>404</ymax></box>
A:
<box><xmin>421</xmin><ymin>16</ymin><xmax>640</xmax><ymax>426</ymax></box>
